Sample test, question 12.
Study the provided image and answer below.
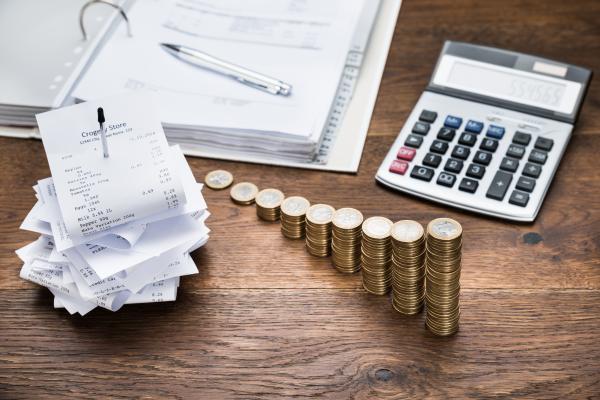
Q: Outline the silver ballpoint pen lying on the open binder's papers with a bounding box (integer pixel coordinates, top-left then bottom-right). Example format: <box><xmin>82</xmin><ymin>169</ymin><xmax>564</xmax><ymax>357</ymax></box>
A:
<box><xmin>160</xmin><ymin>43</ymin><xmax>292</xmax><ymax>96</ymax></box>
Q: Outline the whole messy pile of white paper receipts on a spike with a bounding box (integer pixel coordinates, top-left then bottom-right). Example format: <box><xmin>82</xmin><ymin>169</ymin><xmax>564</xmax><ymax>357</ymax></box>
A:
<box><xmin>17</xmin><ymin>93</ymin><xmax>209</xmax><ymax>315</ymax></box>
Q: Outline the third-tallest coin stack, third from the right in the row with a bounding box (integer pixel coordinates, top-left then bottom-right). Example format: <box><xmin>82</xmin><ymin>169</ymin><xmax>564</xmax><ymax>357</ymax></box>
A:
<box><xmin>360</xmin><ymin>217</ymin><xmax>393</xmax><ymax>295</ymax></box>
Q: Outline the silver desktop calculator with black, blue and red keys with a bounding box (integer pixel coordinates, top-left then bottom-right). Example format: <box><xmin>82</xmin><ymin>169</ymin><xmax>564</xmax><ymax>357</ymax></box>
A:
<box><xmin>376</xmin><ymin>41</ymin><xmax>592</xmax><ymax>221</ymax></box>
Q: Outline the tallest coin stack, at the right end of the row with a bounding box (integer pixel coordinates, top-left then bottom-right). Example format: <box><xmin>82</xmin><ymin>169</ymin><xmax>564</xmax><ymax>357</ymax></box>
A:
<box><xmin>425</xmin><ymin>218</ymin><xmax>462</xmax><ymax>336</ymax></box>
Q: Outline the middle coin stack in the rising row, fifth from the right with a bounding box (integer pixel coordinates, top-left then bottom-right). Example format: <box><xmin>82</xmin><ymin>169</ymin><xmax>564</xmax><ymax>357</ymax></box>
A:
<box><xmin>306</xmin><ymin>204</ymin><xmax>335</xmax><ymax>257</ymax></box>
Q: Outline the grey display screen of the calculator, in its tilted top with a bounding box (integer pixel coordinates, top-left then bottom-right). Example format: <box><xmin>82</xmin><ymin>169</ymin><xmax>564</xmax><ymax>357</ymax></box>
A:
<box><xmin>433</xmin><ymin>54</ymin><xmax>582</xmax><ymax>114</ymax></box>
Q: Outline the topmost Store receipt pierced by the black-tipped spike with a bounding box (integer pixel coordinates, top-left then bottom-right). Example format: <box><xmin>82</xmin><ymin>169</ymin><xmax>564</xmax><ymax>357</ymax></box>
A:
<box><xmin>37</xmin><ymin>93</ymin><xmax>186</xmax><ymax>242</ymax></box>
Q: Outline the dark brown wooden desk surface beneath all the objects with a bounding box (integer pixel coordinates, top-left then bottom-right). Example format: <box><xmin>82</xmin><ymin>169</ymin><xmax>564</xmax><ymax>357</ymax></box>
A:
<box><xmin>0</xmin><ymin>0</ymin><xmax>600</xmax><ymax>399</ymax></box>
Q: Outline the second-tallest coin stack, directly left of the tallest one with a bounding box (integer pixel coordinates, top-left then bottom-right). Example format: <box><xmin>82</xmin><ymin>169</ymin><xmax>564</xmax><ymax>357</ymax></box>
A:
<box><xmin>392</xmin><ymin>220</ymin><xmax>425</xmax><ymax>315</ymax></box>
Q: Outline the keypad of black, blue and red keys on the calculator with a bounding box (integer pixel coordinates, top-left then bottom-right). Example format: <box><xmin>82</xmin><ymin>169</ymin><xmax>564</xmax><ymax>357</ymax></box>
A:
<box><xmin>380</xmin><ymin>97</ymin><xmax>563</xmax><ymax>222</ymax></box>
